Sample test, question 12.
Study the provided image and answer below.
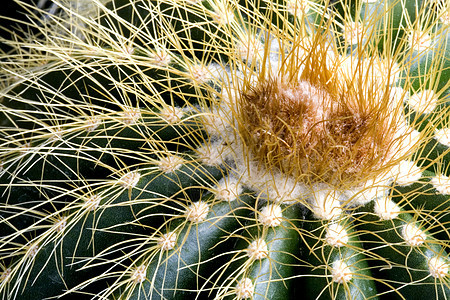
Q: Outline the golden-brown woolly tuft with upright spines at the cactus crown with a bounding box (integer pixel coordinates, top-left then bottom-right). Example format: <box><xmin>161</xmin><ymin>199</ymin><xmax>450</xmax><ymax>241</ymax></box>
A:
<box><xmin>239</xmin><ymin>35</ymin><xmax>408</xmax><ymax>187</ymax></box>
